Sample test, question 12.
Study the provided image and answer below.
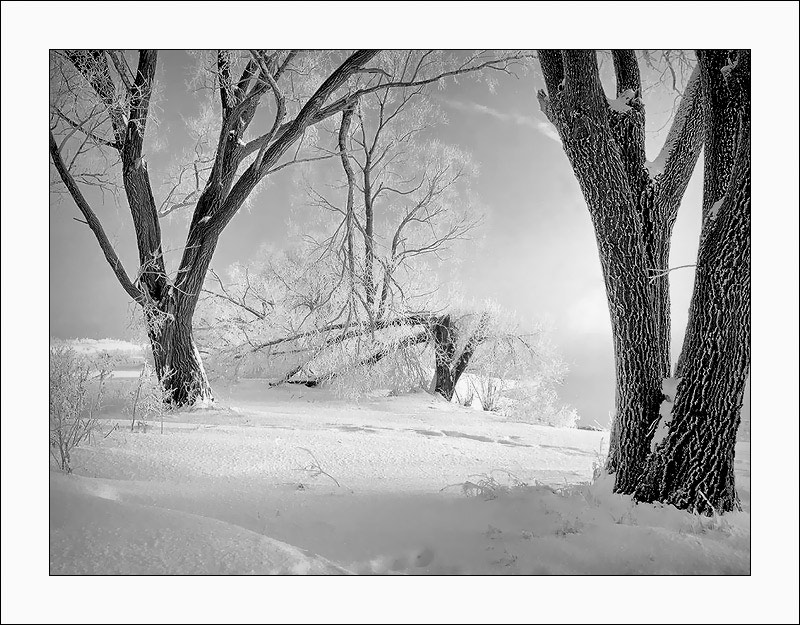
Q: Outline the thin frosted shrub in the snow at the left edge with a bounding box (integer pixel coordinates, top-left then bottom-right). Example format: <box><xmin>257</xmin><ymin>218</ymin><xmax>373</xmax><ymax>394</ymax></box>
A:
<box><xmin>50</xmin><ymin>346</ymin><xmax>114</xmax><ymax>473</ymax></box>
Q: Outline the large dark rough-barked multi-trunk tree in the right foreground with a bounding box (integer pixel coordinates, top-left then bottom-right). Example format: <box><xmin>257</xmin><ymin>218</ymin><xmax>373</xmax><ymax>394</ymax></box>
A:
<box><xmin>539</xmin><ymin>50</ymin><xmax>750</xmax><ymax>511</ymax></box>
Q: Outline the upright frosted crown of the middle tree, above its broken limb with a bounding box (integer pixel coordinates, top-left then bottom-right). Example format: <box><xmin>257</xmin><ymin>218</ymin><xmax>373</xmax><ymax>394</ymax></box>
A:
<box><xmin>308</xmin><ymin>62</ymin><xmax>481</xmax><ymax>330</ymax></box>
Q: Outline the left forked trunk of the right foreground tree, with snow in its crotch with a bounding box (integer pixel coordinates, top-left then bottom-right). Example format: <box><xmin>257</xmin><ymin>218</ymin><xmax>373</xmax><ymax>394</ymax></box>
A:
<box><xmin>539</xmin><ymin>50</ymin><xmax>703</xmax><ymax>493</ymax></box>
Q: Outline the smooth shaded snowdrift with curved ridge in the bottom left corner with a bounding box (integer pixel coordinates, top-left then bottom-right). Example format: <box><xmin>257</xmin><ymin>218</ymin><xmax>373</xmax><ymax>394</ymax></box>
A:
<box><xmin>50</xmin><ymin>473</ymin><xmax>347</xmax><ymax>575</ymax></box>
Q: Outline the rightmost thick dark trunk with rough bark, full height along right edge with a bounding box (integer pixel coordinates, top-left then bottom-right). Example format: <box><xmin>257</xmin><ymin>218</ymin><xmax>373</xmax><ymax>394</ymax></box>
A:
<box><xmin>636</xmin><ymin>50</ymin><xmax>751</xmax><ymax>514</ymax></box>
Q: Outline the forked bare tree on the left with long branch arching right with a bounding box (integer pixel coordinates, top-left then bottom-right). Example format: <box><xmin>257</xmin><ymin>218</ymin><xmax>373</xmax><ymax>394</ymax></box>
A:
<box><xmin>50</xmin><ymin>50</ymin><xmax>525</xmax><ymax>405</ymax></box>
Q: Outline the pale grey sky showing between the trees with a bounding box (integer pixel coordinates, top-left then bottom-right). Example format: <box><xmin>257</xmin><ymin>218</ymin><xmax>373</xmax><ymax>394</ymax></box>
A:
<box><xmin>50</xmin><ymin>51</ymin><xmax>736</xmax><ymax>424</ymax></box>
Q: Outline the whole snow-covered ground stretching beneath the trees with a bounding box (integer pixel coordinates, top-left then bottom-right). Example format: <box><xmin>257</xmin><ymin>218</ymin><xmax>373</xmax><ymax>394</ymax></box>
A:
<box><xmin>50</xmin><ymin>381</ymin><xmax>750</xmax><ymax>574</ymax></box>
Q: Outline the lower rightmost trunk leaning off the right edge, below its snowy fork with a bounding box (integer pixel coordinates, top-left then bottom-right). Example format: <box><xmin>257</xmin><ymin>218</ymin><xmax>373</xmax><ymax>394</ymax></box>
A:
<box><xmin>636</xmin><ymin>125</ymin><xmax>750</xmax><ymax>513</ymax></box>
